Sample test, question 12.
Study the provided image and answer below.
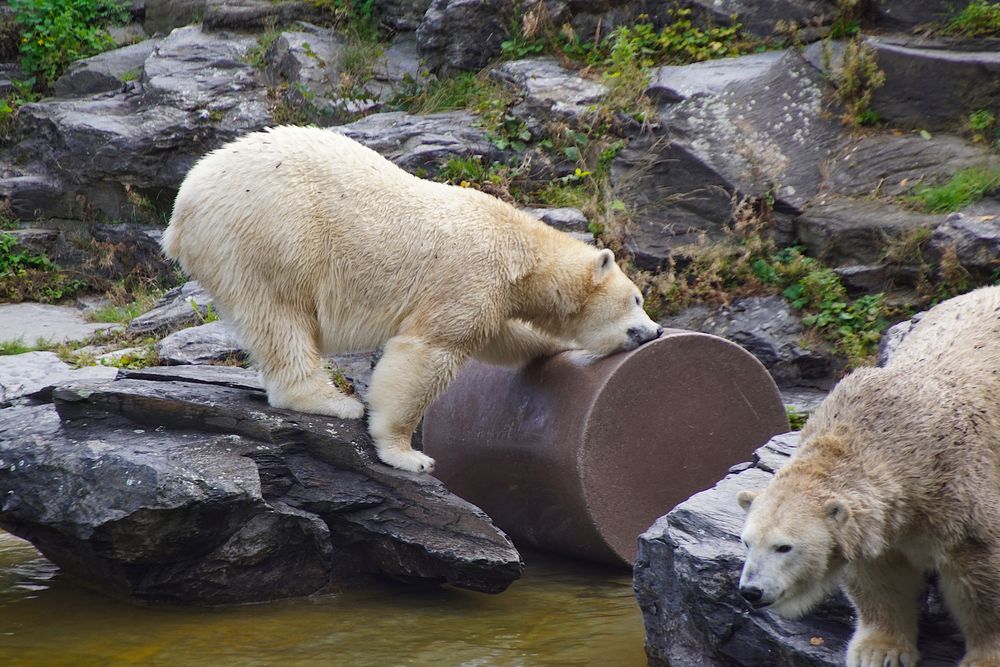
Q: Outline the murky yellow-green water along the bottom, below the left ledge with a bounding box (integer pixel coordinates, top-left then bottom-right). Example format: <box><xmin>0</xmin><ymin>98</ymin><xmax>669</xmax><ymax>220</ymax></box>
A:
<box><xmin>0</xmin><ymin>531</ymin><xmax>646</xmax><ymax>667</ymax></box>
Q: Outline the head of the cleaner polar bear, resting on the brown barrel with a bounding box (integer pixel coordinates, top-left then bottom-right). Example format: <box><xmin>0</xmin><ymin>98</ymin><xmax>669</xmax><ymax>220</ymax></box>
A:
<box><xmin>561</xmin><ymin>249</ymin><xmax>663</xmax><ymax>355</ymax></box>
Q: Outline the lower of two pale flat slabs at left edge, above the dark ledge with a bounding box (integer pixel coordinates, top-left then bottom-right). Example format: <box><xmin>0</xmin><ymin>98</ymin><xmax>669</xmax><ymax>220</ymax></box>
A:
<box><xmin>0</xmin><ymin>352</ymin><xmax>118</xmax><ymax>407</ymax></box>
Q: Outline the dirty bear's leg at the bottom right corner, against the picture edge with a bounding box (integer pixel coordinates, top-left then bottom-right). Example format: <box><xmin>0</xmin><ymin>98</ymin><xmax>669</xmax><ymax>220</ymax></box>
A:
<box><xmin>939</xmin><ymin>544</ymin><xmax>1000</xmax><ymax>667</ymax></box>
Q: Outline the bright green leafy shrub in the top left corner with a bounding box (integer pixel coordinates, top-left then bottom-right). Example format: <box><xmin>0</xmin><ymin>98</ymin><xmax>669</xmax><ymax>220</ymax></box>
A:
<box><xmin>10</xmin><ymin>0</ymin><xmax>130</xmax><ymax>86</ymax></box>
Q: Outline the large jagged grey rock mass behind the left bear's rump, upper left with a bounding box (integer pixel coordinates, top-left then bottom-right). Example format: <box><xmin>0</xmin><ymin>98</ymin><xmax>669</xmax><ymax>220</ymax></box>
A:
<box><xmin>16</xmin><ymin>26</ymin><xmax>271</xmax><ymax>220</ymax></box>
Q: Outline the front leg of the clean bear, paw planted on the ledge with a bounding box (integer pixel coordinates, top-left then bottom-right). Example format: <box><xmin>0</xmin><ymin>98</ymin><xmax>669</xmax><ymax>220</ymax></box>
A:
<box><xmin>368</xmin><ymin>336</ymin><xmax>463</xmax><ymax>472</ymax></box>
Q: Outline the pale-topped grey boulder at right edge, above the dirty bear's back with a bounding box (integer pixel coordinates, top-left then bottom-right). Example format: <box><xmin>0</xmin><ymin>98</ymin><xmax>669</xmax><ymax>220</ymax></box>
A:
<box><xmin>927</xmin><ymin>205</ymin><xmax>1000</xmax><ymax>282</ymax></box>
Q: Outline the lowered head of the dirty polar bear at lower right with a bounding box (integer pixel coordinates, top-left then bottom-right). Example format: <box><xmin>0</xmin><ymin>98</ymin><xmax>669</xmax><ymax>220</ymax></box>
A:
<box><xmin>737</xmin><ymin>480</ymin><xmax>853</xmax><ymax>618</ymax></box>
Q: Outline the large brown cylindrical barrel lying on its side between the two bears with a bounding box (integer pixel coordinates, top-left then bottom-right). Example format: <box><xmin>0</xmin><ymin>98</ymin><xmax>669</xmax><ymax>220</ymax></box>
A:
<box><xmin>423</xmin><ymin>329</ymin><xmax>788</xmax><ymax>564</ymax></box>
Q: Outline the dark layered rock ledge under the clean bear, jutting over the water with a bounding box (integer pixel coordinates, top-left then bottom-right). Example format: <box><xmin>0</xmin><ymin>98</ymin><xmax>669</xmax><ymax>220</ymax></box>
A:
<box><xmin>0</xmin><ymin>366</ymin><xmax>523</xmax><ymax>605</ymax></box>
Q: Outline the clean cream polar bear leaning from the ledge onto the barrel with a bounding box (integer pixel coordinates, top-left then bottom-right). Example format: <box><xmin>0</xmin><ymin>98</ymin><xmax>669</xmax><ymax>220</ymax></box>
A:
<box><xmin>162</xmin><ymin>126</ymin><xmax>662</xmax><ymax>472</ymax></box>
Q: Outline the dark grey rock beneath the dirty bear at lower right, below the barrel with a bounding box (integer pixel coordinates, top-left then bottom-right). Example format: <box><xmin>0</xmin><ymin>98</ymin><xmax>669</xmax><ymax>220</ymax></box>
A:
<box><xmin>634</xmin><ymin>433</ymin><xmax>963</xmax><ymax>667</ymax></box>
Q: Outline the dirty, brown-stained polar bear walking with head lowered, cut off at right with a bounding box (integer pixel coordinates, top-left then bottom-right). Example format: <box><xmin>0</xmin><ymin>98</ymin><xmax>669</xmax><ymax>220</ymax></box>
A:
<box><xmin>738</xmin><ymin>287</ymin><xmax>1000</xmax><ymax>667</ymax></box>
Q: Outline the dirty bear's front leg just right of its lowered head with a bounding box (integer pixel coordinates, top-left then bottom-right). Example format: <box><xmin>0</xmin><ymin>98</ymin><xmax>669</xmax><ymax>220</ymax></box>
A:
<box><xmin>844</xmin><ymin>552</ymin><xmax>924</xmax><ymax>667</ymax></box>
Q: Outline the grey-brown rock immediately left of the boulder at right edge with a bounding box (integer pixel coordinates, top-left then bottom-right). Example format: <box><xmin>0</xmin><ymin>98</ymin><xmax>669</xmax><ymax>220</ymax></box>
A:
<box><xmin>795</xmin><ymin>197</ymin><xmax>942</xmax><ymax>266</ymax></box>
